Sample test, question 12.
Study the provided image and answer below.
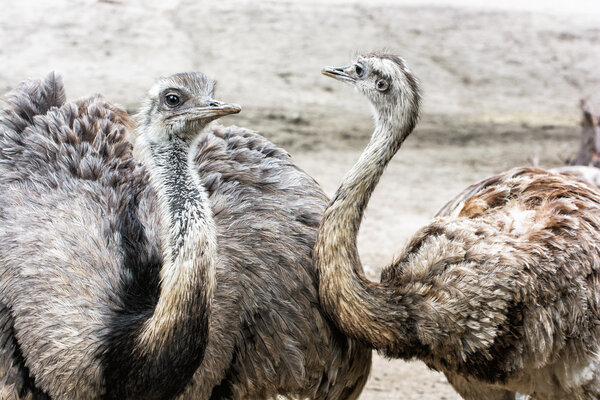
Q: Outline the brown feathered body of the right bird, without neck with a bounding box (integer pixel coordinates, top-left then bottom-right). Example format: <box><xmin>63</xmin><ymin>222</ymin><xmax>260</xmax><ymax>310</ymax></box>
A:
<box><xmin>382</xmin><ymin>168</ymin><xmax>600</xmax><ymax>398</ymax></box>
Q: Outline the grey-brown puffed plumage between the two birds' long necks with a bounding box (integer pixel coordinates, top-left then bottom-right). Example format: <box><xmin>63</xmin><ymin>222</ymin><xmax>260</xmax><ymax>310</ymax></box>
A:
<box><xmin>1</xmin><ymin>72</ymin><xmax>371</xmax><ymax>399</ymax></box>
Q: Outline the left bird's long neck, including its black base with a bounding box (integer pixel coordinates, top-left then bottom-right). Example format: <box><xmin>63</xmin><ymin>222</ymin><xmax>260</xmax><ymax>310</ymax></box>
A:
<box><xmin>108</xmin><ymin>134</ymin><xmax>217</xmax><ymax>399</ymax></box>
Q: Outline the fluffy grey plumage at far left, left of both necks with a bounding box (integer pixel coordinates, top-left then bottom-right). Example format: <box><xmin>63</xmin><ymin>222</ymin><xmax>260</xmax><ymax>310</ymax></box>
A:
<box><xmin>0</xmin><ymin>75</ymin><xmax>162</xmax><ymax>398</ymax></box>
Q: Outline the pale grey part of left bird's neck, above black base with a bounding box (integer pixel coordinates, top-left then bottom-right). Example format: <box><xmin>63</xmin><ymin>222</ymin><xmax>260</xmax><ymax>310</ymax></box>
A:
<box><xmin>139</xmin><ymin>126</ymin><xmax>216</xmax><ymax>357</ymax></box>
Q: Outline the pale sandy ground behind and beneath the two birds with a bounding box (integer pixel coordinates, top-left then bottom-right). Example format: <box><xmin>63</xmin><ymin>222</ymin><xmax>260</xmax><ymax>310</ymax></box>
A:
<box><xmin>0</xmin><ymin>0</ymin><xmax>600</xmax><ymax>400</ymax></box>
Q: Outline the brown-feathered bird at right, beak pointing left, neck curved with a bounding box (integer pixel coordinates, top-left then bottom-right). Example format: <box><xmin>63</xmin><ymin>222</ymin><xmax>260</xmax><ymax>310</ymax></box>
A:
<box><xmin>314</xmin><ymin>54</ymin><xmax>600</xmax><ymax>399</ymax></box>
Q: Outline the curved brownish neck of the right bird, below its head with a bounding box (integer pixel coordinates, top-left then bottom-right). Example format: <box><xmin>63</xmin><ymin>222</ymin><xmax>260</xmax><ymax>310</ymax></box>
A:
<box><xmin>313</xmin><ymin>104</ymin><xmax>416</xmax><ymax>348</ymax></box>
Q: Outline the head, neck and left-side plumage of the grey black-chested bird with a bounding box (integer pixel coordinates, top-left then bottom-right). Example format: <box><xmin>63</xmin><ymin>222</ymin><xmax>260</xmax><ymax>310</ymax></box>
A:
<box><xmin>0</xmin><ymin>73</ymin><xmax>240</xmax><ymax>399</ymax></box>
